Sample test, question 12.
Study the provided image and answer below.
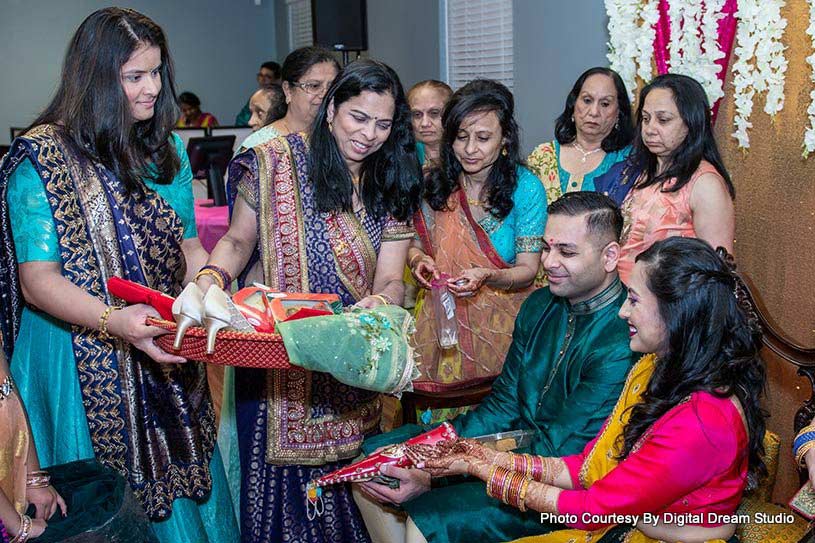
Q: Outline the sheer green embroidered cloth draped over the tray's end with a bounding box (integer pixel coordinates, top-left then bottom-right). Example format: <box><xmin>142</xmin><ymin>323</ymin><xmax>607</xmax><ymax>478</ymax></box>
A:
<box><xmin>277</xmin><ymin>305</ymin><xmax>419</xmax><ymax>394</ymax></box>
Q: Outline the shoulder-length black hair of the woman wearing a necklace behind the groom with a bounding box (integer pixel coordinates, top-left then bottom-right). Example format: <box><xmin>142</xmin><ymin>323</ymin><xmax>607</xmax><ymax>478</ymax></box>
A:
<box><xmin>555</xmin><ymin>66</ymin><xmax>634</xmax><ymax>153</ymax></box>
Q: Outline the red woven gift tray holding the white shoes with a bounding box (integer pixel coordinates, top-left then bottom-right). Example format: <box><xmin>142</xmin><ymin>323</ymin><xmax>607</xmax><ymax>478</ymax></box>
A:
<box><xmin>147</xmin><ymin>318</ymin><xmax>295</xmax><ymax>369</ymax></box>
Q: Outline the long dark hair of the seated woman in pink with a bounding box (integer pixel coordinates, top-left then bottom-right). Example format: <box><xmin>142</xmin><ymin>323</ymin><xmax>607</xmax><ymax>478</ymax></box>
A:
<box><xmin>621</xmin><ymin>237</ymin><xmax>766</xmax><ymax>488</ymax></box>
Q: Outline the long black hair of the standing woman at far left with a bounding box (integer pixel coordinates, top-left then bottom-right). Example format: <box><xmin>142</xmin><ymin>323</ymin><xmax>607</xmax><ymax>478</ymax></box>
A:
<box><xmin>31</xmin><ymin>8</ymin><xmax>180</xmax><ymax>191</ymax></box>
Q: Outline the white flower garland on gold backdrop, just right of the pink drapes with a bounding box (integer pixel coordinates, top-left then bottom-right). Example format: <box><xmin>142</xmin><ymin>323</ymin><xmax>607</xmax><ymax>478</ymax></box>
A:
<box><xmin>733</xmin><ymin>0</ymin><xmax>787</xmax><ymax>149</ymax></box>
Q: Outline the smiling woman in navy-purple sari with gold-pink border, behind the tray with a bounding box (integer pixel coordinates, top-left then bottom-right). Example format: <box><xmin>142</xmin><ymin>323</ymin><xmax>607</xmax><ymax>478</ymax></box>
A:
<box><xmin>192</xmin><ymin>60</ymin><xmax>420</xmax><ymax>543</ymax></box>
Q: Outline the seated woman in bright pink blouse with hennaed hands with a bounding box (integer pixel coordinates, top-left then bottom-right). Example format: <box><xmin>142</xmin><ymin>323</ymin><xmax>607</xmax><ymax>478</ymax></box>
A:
<box><xmin>419</xmin><ymin>237</ymin><xmax>766</xmax><ymax>543</ymax></box>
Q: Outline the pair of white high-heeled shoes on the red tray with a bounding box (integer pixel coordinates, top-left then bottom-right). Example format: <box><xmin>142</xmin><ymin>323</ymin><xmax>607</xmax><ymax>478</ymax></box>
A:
<box><xmin>173</xmin><ymin>283</ymin><xmax>255</xmax><ymax>354</ymax></box>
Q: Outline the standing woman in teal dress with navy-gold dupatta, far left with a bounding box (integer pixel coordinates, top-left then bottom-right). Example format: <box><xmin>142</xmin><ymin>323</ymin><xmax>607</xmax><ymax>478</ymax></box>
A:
<box><xmin>0</xmin><ymin>8</ymin><xmax>238</xmax><ymax>542</ymax></box>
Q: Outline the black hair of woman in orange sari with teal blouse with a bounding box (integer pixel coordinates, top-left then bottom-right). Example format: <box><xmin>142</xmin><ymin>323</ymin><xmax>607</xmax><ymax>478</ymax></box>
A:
<box><xmin>425</xmin><ymin>79</ymin><xmax>523</xmax><ymax>219</ymax></box>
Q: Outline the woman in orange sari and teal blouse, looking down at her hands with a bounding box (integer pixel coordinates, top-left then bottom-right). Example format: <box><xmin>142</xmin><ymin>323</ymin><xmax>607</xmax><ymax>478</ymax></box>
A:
<box><xmin>408</xmin><ymin>80</ymin><xmax>546</xmax><ymax>392</ymax></box>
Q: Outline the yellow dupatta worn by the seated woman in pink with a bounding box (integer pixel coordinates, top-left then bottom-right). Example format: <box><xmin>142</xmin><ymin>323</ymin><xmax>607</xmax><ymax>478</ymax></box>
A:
<box><xmin>514</xmin><ymin>354</ymin><xmax>725</xmax><ymax>543</ymax></box>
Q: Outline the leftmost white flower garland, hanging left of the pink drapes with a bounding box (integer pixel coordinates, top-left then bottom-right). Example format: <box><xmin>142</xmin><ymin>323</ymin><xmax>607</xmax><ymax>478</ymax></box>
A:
<box><xmin>605</xmin><ymin>0</ymin><xmax>659</xmax><ymax>102</ymax></box>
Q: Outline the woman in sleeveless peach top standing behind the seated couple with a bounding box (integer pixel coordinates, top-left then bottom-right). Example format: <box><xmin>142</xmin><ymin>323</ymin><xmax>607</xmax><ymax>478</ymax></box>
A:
<box><xmin>618</xmin><ymin>74</ymin><xmax>736</xmax><ymax>284</ymax></box>
